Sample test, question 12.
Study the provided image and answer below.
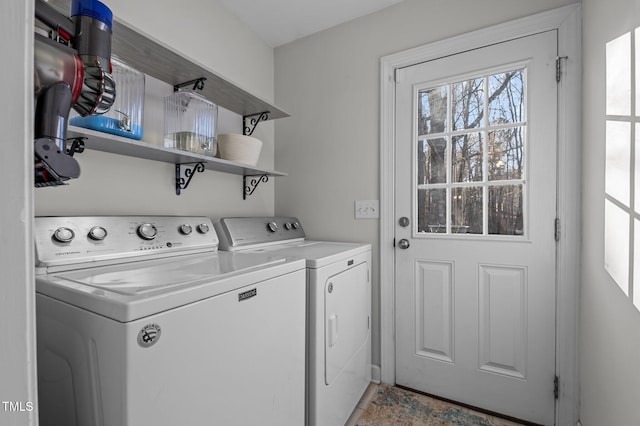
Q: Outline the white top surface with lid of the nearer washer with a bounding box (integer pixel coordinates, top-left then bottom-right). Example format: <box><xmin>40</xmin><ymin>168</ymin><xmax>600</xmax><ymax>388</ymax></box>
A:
<box><xmin>36</xmin><ymin>252</ymin><xmax>304</xmax><ymax>322</ymax></box>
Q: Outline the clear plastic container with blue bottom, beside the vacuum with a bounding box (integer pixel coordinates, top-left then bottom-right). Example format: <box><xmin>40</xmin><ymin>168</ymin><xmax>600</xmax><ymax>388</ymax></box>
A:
<box><xmin>69</xmin><ymin>56</ymin><xmax>145</xmax><ymax>140</ymax></box>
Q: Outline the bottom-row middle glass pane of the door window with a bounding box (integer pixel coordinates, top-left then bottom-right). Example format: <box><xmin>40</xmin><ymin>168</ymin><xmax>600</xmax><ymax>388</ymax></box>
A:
<box><xmin>451</xmin><ymin>186</ymin><xmax>483</xmax><ymax>234</ymax></box>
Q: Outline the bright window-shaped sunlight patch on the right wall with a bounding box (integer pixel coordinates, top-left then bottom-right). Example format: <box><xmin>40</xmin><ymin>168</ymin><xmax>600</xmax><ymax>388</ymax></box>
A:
<box><xmin>604</xmin><ymin>28</ymin><xmax>640</xmax><ymax>309</ymax></box>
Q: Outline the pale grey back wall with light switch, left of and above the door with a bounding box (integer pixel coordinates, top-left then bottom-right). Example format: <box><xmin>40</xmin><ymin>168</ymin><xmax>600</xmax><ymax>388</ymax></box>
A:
<box><xmin>275</xmin><ymin>0</ymin><xmax>573</xmax><ymax>372</ymax></box>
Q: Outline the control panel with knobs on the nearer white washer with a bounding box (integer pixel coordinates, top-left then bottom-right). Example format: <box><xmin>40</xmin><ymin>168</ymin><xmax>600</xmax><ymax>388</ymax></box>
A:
<box><xmin>34</xmin><ymin>216</ymin><xmax>218</xmax><ymax>267</ymax></box>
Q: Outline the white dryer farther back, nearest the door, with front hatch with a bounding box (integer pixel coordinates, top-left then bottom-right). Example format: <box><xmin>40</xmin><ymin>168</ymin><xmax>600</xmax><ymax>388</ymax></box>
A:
<box><xmin>214</xmin><ymin>217</ymin><xmax>371</xmax><ymax>426</ymax></box>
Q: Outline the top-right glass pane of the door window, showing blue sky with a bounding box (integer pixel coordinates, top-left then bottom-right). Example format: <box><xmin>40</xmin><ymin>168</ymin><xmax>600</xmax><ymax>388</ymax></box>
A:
<box><xmin>488</xmin><ymin>70</ymin><xmax>525</xmax><ymax>125</ymax></box>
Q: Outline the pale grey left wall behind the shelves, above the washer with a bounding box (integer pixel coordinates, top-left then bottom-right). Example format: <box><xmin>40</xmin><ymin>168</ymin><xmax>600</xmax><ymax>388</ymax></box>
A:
<box><xmin>35</xmin><ymin>0</ymin><xmax>275</xmax><ymax>217</ymax></box>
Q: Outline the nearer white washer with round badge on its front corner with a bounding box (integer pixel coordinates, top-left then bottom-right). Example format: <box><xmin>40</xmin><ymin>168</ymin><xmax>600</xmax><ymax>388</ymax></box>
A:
<box><xmin>35</xmin><ymin>216</ymin><xmax>306</xmax><ymax>426</ymax></box>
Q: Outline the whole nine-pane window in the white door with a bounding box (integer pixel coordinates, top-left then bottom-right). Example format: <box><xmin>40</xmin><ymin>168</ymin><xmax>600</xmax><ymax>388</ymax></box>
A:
<box><xmin>416</xmin><ymin>68</ymin><xmax>527</xmax><ymax>236</ymax></box>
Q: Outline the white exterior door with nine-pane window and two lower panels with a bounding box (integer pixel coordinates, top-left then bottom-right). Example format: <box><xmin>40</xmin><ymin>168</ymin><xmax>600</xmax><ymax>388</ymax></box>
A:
<box><xmin>395</xmin><ymin>31</ymin><xmax>557</xmax><ymax>425</ymax></box>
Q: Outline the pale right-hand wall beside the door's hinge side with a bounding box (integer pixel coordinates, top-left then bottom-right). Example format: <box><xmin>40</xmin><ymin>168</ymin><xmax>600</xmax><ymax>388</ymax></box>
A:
<box><xmin>579</xmin><ymin>0</ymin><xmax>640</xmax><ymax>426</ymax></box>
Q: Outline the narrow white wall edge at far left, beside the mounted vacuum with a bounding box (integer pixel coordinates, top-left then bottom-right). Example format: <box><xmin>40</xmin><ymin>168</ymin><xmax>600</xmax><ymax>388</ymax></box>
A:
<box><xmin>0</xmin><ymin>0</ymin><xmax>37</xmax><ymax>426</ymax></box>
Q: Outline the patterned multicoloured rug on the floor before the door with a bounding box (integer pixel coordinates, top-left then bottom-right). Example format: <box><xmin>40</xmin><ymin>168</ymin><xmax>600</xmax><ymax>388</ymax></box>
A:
<box><xmin>356</xmin><ymin>385</ymin><xmax>520</xmax><ymax>426</ymax></box>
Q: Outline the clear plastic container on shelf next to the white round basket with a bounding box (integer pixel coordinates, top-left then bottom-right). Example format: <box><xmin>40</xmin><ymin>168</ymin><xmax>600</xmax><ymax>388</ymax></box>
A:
<box><xmin>164</xmin><ymin>91</ymin><xmax>218</xmax><ymax>156</ymax></box>
